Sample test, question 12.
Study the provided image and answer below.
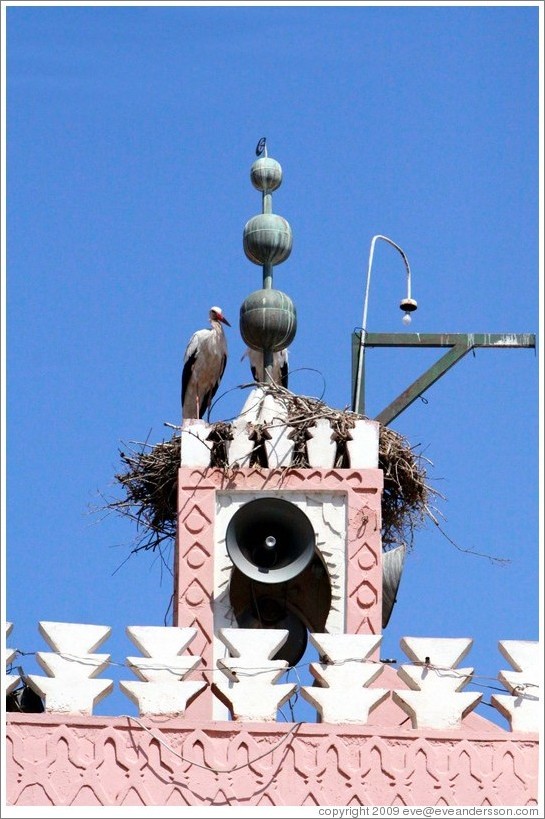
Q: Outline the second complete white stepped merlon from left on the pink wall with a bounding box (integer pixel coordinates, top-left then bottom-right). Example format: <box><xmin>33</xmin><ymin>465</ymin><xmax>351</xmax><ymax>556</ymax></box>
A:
<box><xmin>119</xmin><ymin>626</ymin><xmax>206</xmax><ymax>717</ymax></box>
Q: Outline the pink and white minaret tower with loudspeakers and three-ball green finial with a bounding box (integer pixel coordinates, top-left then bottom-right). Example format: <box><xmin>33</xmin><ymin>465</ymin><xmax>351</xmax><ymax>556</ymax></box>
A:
<box><xmin>174</xmin><ymin>141</ymin><xmax>383</xmax><ymax>719</ymax></box>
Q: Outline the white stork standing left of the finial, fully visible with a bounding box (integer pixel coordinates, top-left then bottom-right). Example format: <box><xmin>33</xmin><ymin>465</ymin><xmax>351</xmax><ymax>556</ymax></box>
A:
<box><xmin>182</xmin><ymin>307</ymin><xmax>231</xmax><ymax>418</ymax></box>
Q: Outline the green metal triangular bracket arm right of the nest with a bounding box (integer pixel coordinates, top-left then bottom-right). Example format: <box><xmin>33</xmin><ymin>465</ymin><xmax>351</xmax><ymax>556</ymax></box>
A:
<box><xmin>352</xmin><ymin>331</ymin><xmax>536</xmax><ymax>425</ymax></box>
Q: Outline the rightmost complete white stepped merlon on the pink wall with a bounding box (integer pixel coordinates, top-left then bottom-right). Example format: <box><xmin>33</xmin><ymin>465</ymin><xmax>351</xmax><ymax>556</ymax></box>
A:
<box><xmin>392</xmin><ymin>637</ymin><xmax>482</xmax><ymax>728</ymax></box>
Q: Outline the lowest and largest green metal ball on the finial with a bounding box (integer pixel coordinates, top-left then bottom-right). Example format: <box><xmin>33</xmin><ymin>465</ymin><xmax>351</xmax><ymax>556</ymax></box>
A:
<box><xmin>240</xmin><ymin>289</ymin><xmax>297</xmax><ymax>353</ymax></box>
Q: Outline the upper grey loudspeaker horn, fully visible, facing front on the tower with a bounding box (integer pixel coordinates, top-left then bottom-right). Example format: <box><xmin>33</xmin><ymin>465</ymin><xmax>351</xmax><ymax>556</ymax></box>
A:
<box><xmin>225</xmin><ymin>498</ymin><xmax>316</xmax><ymax>583</ymax></box>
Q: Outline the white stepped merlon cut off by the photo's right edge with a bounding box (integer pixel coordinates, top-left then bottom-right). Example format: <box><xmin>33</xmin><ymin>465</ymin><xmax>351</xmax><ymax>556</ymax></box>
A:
<box><xmin>491</xmin><ymin>640</ymin><xmax>543</xmax><ymax>733</ymax></box>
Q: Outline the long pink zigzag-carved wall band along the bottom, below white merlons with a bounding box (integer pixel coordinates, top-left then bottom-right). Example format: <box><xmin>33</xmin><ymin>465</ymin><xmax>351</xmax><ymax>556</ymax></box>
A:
<box><xmin>6</xmin><ymin>714</ymin><xmax>538</xmax><ymax>807</ymax></box>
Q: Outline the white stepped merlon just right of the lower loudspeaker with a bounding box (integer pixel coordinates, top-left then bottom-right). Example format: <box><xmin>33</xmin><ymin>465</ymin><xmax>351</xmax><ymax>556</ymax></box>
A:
<box><xmin>301</xmin><ymin>634</ymin><xmax>390</xmax><ymax>725</ymax></box>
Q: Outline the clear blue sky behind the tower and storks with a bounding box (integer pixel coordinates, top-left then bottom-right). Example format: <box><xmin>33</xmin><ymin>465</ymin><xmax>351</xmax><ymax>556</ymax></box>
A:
<box><xmin>3</xmin><ymin>3</ymin><xmax>543</xmax><ymax>725</ymax></box>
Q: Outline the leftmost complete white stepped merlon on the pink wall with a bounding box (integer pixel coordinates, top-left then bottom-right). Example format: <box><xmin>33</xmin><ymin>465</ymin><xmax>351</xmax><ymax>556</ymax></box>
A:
<box><xmin>28</xmin><ymin>621</ymin><xmax>114</xmax><ymax>715</ymax></box>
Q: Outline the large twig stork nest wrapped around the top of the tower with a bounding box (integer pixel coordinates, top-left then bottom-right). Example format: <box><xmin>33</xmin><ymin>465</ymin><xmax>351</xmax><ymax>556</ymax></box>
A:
<box><xmin>103</xmin><ymin>385</ymin><xmax>439</xmax><ymax>552</ymax></box>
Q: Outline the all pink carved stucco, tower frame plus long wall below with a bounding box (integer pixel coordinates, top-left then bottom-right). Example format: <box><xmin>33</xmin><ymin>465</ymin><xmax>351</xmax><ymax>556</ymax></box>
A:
<box><xmin>6</xmin><ymin>468</ymin><xmax>538</xmax><ymax>807</ymax></box>
